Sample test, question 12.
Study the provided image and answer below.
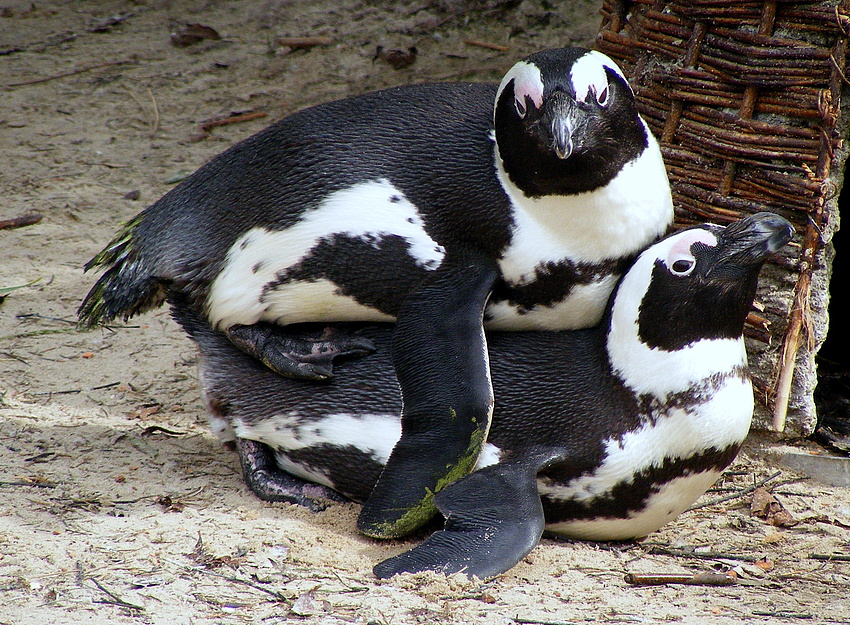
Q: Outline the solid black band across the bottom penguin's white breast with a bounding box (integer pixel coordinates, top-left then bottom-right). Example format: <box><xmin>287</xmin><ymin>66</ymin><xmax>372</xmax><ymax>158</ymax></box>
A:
<box><xmin>540</xmin><ymin>445</ymin><xmax>741</xmax><ymax>523</ymax></box>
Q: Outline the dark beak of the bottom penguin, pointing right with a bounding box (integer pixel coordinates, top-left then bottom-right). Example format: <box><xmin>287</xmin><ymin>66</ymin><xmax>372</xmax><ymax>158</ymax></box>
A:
<box><xmin>710</xmin><ymin>213</ymin><xmax>794</xmax><ymax>274</ymax></box>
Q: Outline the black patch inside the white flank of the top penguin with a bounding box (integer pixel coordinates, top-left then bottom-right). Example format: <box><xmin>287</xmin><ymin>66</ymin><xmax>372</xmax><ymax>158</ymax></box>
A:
<box><xmin>263</xmin><ymin>233</ymin><xmax>428</xmax><ymax>315</ymax></box>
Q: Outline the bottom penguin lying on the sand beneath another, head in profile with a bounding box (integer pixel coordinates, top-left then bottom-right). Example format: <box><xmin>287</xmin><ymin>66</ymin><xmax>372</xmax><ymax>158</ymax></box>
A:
<box><xmin>172</xmin><ymin>213</ymin><xmax>794</xmax><ymax>578</ymax></box>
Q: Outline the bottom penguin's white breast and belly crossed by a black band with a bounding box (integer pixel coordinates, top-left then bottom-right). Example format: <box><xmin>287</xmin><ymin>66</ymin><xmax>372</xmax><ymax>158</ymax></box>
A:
<box><xmin>538</xmin><ymin>368</ymin><xmax>753</xmax><ymax>540</ymax></box>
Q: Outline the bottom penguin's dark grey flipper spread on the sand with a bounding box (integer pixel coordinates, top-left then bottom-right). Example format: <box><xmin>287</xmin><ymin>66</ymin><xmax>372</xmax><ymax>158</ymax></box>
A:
<box><xmin>373</xmin><ymin>448</ymin><xmax>566</xmax><ymax>579</ymax></box>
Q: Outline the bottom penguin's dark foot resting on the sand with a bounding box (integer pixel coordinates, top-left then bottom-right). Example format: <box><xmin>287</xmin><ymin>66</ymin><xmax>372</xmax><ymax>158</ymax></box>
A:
<box><xmin>236</xmin><ymin>438</ymin><xmax>348</xmax><ymax>512</ymax></box>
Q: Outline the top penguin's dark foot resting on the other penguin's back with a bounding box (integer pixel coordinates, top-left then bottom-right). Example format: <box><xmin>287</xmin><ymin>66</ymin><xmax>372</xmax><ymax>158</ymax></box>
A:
<box><xmin>224</xmin><ymin>321</ymin><xmax>375</xmax><ymax>380</ymax></box>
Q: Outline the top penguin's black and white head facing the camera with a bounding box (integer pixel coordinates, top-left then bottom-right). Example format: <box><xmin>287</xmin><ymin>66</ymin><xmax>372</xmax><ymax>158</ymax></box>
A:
<box><xmin>494</xmin><ymin>48</ymin><xmax>648</xmax><ymax>197</ymax></box>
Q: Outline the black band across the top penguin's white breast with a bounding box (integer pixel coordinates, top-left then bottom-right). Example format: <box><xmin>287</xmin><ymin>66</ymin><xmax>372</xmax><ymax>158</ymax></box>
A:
<box><xmin>490</xmin><ymin>257</ymin><xmax>633</xmax><ymax>314</ymax></box>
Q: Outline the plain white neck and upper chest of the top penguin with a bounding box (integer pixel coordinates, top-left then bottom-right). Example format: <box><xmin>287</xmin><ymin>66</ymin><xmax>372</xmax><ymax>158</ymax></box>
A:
<box><xmin>494</xmin><ymin>124</ymin><xmax>673</xmax><ymax>263</ymax></box>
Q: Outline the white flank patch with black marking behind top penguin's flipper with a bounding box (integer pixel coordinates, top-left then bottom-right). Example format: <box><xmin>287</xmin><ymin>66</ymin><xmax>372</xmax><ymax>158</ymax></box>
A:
<box><xmin>207</xmin><ymin>179</ymin><xmax>445</xmax><ymax>327</ymax></box>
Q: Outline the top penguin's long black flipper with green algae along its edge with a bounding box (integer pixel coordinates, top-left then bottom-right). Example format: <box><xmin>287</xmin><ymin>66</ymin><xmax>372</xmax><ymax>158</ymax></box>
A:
<box><xmin>357</xmin><ymin>252</ymin><xmax>499</xmax><ymax>538</ymax></box>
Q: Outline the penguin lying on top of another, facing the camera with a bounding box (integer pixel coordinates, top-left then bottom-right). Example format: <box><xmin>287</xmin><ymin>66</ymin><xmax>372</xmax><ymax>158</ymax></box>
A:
<box><xmin>78</xmin><ymin>48</ymin><xmax>673</xmax><ymax>538</ymax></box>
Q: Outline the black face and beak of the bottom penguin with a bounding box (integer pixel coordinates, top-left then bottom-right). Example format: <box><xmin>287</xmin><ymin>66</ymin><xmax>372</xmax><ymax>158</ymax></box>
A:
<box><xmin>638</xmin><ymin>213</ymin><xmax>794</xmax><ymax>351</ymax></box>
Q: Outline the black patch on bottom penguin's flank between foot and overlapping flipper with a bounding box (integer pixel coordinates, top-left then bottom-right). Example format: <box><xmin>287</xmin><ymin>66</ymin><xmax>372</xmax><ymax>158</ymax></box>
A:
<box><xmin>285</xmin><ymin>444</ymin><xmax>383</xmax><ymax>503</ymax></box>
